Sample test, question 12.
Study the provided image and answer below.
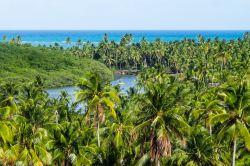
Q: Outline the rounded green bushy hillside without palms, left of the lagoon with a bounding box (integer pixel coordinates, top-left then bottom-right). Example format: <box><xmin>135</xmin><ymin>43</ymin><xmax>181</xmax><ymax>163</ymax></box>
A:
<box><xmin>0</xmin><ymin>43</ymin><xmax>113</xmax><ymax>87</ymax></box>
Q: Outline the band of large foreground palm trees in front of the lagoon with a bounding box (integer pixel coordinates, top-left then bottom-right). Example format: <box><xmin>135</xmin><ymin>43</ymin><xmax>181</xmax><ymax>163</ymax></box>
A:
<box><xmin>0</xmin><ymin>68</ymin><xmax>250</xmax><ymax>166</ymax></box>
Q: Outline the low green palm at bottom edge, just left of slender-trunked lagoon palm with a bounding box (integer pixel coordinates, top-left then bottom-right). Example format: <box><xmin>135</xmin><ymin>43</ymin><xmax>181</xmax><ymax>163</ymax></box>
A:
<box><xmin>47</xmin><ymin>120</ymin><xmax>97</xmax><ymax>166</ymax></box>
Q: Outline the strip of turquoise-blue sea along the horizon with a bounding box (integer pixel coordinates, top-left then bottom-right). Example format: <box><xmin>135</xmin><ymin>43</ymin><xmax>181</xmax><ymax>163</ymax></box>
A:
<box><xmin>0</xmin><ymin>30</ymin><xmax>250</xmax><ymax>46</ymax></box>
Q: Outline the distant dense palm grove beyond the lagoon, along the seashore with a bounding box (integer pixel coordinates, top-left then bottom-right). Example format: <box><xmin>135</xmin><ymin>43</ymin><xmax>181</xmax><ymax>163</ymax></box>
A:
<box><xmin>65</xmin><ymin>33</ymin><xmax>250</xmax><ymax>75</ymax></box>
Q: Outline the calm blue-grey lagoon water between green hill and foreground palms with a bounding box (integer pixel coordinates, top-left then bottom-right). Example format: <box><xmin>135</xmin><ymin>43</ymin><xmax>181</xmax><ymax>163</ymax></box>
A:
<box><xmin>47</xmin><ymin>75</ymin><xmax>136</xmax><ymax>101</ymax></box>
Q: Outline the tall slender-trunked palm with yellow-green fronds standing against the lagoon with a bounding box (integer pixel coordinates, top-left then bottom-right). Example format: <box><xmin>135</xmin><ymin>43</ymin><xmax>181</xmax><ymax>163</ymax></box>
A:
<box><xmin>76</xmin><ymin>73</ymin><xmax>119</xmax><ymax>148</ymax></box>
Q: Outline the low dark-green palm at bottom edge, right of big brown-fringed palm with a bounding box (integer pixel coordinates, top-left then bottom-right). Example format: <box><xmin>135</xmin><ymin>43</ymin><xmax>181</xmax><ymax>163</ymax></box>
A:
<box><xmin>168</xmin><ymin>126</ymin><xmax>223</xmax><ymax>166</ymax></box>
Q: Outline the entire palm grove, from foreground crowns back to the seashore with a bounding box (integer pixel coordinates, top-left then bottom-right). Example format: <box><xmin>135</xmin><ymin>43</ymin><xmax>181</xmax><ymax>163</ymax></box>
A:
<box><xmin>0</xmin><ymin>34</ymin><xmax>250</xmax><ymax>166</ymax></box>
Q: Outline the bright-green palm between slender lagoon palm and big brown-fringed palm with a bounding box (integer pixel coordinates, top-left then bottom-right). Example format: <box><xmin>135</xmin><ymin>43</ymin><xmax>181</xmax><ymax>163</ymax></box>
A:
<box><xmin>102</xmin><ymin>110</ymin><xmax>134</xmax><ymax>165</ymax></box>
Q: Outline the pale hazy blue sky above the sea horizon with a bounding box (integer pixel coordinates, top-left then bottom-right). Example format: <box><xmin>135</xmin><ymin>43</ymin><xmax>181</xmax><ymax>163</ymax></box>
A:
<box><xmin>0</xmin><ymin>0</ymin><xmax>250</xmax><ymax>30</ymax></box>
